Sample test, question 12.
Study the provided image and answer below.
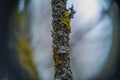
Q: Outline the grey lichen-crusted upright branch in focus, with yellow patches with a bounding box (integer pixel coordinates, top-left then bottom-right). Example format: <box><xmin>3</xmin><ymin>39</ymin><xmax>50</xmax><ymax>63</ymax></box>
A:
<box><xmin>51</xmin><ymin>0</ymin><xmax>75</xmax><ymax>80</ymax></box>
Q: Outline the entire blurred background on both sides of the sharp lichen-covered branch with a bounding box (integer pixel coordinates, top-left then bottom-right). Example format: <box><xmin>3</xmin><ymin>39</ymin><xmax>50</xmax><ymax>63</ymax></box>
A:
<box><xmin>0</xmin><ymin>0</ymin><xmax>120</xmax><ymax>80</ymax></box>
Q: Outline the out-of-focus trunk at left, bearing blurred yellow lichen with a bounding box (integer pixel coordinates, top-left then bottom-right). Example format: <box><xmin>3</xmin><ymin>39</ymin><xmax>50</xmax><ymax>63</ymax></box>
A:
<box><xmin>10</xmin><ymin>1</ymin><xmax>39</xmax><ymax>80</ymax></box>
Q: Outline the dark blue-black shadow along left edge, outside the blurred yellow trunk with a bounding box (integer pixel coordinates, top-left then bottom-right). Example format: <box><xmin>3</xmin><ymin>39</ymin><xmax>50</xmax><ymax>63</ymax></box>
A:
<box><xmin>0</xmin><ymin>0</ymin><xmax>30</xmax><ymax>80</ymax></box>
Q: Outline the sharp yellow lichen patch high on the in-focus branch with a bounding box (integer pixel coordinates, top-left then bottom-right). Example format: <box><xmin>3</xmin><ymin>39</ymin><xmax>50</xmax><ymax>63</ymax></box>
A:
<box><xmin>62</xmin><ymin>12</ymin><xmax>71</xmax><ymax>32</ymax></box>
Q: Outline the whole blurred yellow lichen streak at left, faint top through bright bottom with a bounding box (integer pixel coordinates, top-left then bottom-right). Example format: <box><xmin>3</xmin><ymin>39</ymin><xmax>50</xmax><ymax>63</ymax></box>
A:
<box><xmin>12</xmin><ymin>6</ymin><xmax>38</xmax><ymax>80</ymax></box>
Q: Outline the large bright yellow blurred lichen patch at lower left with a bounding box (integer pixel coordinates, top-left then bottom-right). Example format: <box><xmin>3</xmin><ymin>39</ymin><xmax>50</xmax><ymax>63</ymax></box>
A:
<box><xmin>17</xmin><ymin>35</ymin><xmax>37</xmax><ymax>80</ymax></box>
